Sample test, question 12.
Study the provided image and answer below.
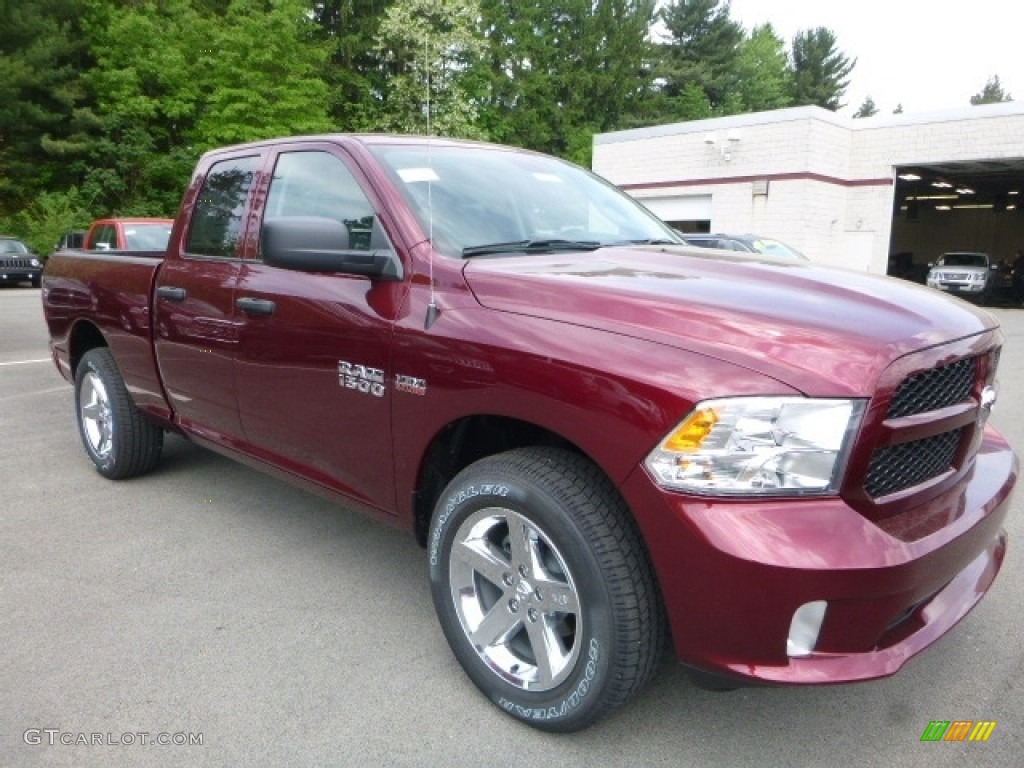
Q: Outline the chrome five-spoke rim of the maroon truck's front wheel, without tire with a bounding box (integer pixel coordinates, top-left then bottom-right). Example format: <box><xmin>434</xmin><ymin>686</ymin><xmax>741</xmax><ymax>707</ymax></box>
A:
<box><xmin>449</xmin><ymin>507</ymin><xmax>583</xmax><ymax>691</ymax></box>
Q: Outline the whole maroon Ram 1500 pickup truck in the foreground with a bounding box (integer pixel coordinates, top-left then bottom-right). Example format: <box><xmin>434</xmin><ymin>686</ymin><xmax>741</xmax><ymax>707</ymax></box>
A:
<box><xmin>43</xmin><ymin>135</ymin><xmax>1018</xmax><ymax>731</ymax></box>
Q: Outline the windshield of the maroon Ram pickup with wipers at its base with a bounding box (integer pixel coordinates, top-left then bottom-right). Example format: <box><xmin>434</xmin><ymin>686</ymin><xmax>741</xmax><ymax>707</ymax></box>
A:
<box><xmin>371</xmin><ymin>145</ymin><xmax>682</xmax><ymax>258</ymax></box>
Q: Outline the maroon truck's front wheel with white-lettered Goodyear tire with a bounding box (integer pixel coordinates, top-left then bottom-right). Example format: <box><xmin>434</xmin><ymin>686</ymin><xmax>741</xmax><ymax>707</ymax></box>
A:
<box><xmin>428</xmin><ymin>447</ymin><xmax>666</xmax><ymax>732</ymax></box>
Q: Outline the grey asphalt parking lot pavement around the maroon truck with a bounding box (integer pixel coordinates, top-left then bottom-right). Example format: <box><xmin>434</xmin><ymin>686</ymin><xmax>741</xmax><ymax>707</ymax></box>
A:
<box><xmin>0</xmin><ymin>288</ymin><xmax>1024</xmax><ymax>768</ymax></box>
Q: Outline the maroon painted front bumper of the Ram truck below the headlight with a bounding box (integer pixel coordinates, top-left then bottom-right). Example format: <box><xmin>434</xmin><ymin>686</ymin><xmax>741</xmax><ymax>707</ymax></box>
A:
<box><xmin>623</xmin><ymin>429</ymin><xmax>1019</xmax><ymax>683</ymax></box>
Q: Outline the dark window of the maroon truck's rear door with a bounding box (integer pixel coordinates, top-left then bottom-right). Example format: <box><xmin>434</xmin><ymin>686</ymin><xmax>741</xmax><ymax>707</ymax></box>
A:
<box><xmin>185</xmin><ymin>156</ymin><xmax>259</xmax><ymax>258</ymax></box>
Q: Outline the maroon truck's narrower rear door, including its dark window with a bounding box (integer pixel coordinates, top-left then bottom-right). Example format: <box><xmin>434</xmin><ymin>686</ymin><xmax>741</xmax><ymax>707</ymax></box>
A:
<box><xmin>154</xmin><ymin>153</ymin><xmax>263</xmax><ymax>444</ymax></box>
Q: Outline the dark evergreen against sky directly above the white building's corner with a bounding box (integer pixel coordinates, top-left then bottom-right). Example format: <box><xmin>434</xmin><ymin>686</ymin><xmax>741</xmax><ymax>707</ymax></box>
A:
<box><xmin>793</xmin><ymin>27</ymin><xmax>857</xmax><ymax>112</ymax></box>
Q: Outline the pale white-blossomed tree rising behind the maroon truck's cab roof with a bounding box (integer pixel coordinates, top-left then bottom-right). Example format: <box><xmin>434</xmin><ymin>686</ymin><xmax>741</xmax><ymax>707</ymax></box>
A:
<box><xmin>376</xmin><ymin>0</ymin><xmax>485</xmax><ymax>138</ymax></box>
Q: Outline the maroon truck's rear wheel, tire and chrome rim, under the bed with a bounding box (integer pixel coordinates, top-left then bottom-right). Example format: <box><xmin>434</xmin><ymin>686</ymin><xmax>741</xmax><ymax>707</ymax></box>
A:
<box><xmin>75</xmin><ymin>347</ymin><xmax>164</xmax><ymax>480</ymax></box>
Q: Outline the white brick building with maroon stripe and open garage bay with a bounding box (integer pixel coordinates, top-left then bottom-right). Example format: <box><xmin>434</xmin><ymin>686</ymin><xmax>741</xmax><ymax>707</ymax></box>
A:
<box><xmin>593</xmin><ymin>101</ymin><xmax>1024</xmax><ymax>272</ymax></box>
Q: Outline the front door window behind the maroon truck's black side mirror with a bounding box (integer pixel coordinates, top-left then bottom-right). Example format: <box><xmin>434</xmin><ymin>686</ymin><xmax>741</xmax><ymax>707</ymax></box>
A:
<box><xmin>264</xmin><ymin>152</ymin><xmax>389</xmax><ymax>251</ymax></box>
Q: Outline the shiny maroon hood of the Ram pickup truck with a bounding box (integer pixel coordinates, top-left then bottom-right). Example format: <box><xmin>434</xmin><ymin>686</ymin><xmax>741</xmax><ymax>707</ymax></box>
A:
<box><xmin>465</xmin><ymin>246</ymin><xmax>997</xmax><ymax>396</ymax></box>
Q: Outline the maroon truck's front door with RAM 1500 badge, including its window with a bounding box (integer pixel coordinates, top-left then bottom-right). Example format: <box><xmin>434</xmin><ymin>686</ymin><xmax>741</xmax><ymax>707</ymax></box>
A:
<box><xmin>236</xmin><ymin>143</ymin><xmax>406</xmax><ymax>510</ymax></box>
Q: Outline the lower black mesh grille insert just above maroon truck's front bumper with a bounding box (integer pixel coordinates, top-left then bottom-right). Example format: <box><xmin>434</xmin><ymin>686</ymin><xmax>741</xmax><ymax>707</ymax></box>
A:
<box><xmin>864</xmin><ymin>429</ymin><xmax>963</xmax><ymax>499</ymax></box>
